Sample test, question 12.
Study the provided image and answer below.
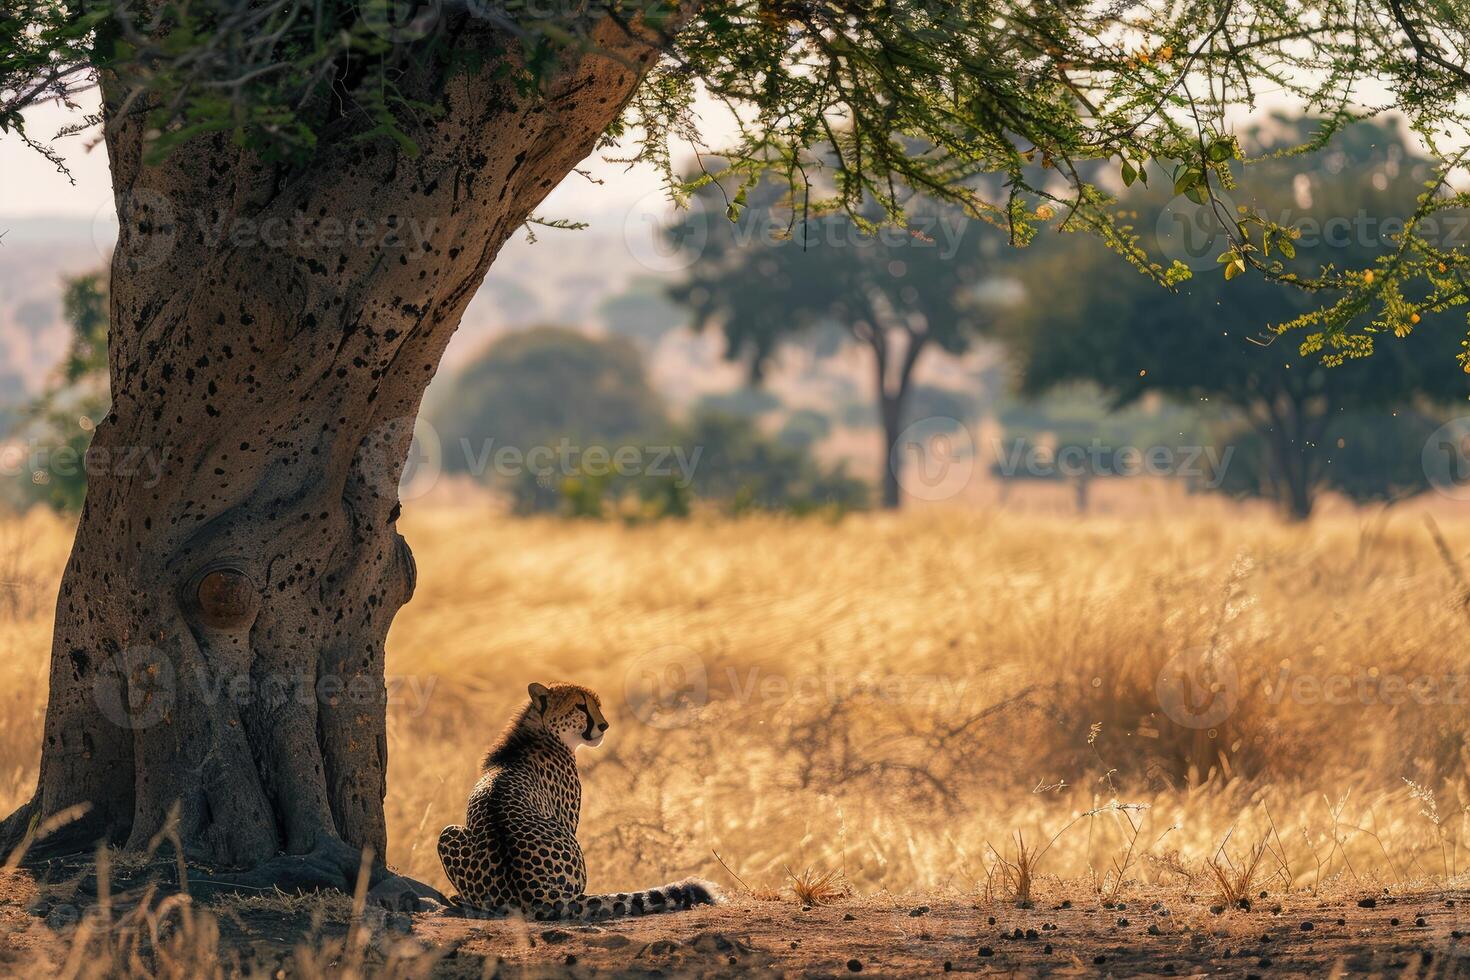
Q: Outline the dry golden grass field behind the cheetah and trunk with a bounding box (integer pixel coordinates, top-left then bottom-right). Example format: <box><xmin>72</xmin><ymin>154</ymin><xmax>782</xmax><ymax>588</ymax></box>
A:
<box><xmin>0</xmin><ymin>507</ymin><xmax>1470</xmax><ymax>916</ymax></box>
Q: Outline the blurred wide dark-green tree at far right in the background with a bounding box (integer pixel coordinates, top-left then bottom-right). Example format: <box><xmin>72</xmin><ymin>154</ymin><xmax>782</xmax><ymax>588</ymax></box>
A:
<box><xmin>994</xmin><ymin>120</ymin><xmax>1470</xmax><ymax>519</ymax></box>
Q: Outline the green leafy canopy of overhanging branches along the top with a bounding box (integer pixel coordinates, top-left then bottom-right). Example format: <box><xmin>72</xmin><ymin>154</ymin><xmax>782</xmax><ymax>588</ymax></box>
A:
<box><xmin>0</xmin><ymin>0</ymin><xmax>1470</xmax><ymax>362</ymax></box>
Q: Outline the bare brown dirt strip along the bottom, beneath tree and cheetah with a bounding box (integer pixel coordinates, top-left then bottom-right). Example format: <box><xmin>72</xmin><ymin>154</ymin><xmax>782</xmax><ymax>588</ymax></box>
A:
<box><xmin>0</xmin><ymin>884</ymin><xmax>1470</xmax><ymax>977</ymax></box>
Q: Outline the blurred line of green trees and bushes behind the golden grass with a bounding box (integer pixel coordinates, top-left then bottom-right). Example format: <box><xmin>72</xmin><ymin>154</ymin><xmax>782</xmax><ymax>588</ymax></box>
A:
<box><xmin>10</xmin><ymin>120</ymin><xmax>1470</xmax><ymax>519</ymax></box>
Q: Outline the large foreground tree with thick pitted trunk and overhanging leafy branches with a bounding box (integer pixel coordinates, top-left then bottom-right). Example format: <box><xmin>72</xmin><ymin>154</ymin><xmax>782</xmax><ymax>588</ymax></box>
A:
<box><xmin>0</xmin><ymin>0</ymin><xmax>1470</xmax><ymax>886</ymax></box>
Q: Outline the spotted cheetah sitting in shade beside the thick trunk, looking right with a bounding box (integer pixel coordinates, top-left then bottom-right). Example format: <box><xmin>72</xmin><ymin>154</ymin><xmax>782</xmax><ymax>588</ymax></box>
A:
<box><xmin>440</xmin><ymin>683</ymin><xmax>720</xmax><ymax>920</ymax></box>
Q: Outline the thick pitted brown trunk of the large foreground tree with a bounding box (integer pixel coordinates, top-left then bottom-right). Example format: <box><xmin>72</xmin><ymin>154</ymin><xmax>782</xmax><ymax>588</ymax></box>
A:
<box><xmin>0</xmin><ymin>11</ymin><xmax>667</xmax><ymax>884</ymax></box>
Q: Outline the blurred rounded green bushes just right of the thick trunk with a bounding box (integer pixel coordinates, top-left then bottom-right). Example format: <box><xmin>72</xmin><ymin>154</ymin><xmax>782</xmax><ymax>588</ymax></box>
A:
<box><xmin>429</xmin><ymin>326</ymin><xmax>867</xmax><ymax>520</ymax></box>
